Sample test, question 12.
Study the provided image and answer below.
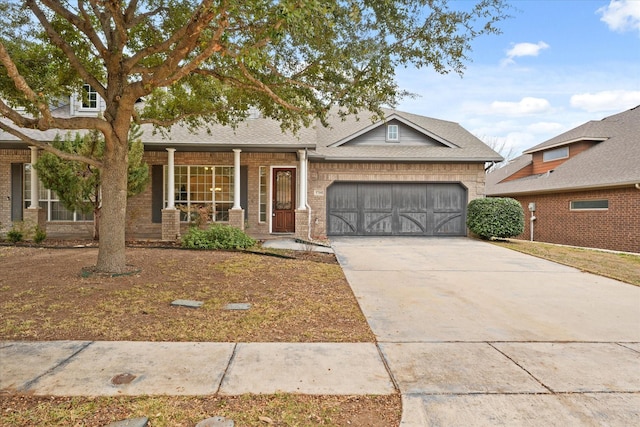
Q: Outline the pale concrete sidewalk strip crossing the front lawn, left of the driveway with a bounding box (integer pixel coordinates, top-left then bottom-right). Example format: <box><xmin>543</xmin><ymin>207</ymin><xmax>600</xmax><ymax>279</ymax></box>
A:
<box><xmin>0</xmin><ymin>341</ymin><xmax>396</xmax><ymax>396</ymax></box>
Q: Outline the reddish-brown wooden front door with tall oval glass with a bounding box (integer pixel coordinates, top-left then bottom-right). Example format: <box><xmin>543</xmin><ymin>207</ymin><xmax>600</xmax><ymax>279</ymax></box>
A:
<box><xmin>272</xmin><ymin>168</ymin><xmax>296</xmax><ymax>233</ymax></box>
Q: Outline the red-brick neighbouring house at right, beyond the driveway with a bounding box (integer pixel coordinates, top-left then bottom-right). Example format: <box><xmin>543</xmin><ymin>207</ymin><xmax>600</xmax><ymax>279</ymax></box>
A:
<box><xmin>487</xmin><ymin>106</ymin><xmax>640</xmax><ymax>253</ymax></box>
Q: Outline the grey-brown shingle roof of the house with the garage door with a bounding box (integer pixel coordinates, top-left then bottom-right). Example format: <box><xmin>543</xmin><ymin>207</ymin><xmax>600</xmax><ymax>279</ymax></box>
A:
<box><xmin>0</xmin><ymin>105</ymin><xmax>502</xmax><ymax>162</ymax></box>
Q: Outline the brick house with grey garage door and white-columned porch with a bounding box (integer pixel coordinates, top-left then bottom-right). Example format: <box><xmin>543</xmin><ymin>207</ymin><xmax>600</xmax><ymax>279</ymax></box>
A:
<box><xmin>0</xmin><ymin>102</ymin><xmax>501</xmax><ymax>240</ymax></box>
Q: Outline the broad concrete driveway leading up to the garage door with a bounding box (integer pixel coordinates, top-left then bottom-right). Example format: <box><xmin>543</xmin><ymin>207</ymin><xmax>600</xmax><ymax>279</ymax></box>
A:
<box><xmin>333</xmin><ymin>237</ymin><xmax>640</xmax><ymax>427</ymax></box>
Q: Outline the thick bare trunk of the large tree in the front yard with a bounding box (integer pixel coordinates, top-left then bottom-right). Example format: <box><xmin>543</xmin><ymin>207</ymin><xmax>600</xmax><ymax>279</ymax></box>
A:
<box><xmin>96</xmin><ymin>131</ymin><xmax>129</xmax><ymax>273</ymax></box>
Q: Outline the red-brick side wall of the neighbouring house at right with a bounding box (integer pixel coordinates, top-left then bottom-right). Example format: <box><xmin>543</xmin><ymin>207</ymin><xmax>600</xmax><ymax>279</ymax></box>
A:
<box><xmin>515</xmin><ymin>186</ymin><xmax>640</xmax><ymax>253</ymax></box>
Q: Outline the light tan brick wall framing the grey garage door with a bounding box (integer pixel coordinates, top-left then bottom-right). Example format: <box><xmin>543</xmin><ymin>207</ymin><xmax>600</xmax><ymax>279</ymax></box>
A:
<box><xmin>308</xmin><ymin>163</ymin><xmax>485</xmax><ymax>238</ymax></box>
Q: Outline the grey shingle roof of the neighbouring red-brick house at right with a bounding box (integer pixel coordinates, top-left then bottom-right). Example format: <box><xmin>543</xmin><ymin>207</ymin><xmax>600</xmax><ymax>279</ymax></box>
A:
<box><xmin>486</xmin><ymin>106</ymin><xmax>640</xmax><ymax>195</ymax></box>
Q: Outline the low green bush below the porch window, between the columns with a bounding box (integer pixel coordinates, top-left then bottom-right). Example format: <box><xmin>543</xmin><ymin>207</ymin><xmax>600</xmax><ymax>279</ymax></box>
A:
<box><xmin>182</xmin><ymin>224</ymin><xmax>256</xmax><ymax>249</ymax></box>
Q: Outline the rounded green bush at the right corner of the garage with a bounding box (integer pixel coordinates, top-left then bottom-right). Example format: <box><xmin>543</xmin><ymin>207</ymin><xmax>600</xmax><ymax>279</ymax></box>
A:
<box><xmin>467</xmin><ymin>197</ymin><xmax>524</xmax><ymax>239</ymax></box>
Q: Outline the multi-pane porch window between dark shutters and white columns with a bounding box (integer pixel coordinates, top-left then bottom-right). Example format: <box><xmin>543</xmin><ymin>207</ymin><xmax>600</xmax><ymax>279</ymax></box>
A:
<box><xmin>165</xmin><ymin>166</ymin><xmax>234</xmax><ymax>222</ymax></box>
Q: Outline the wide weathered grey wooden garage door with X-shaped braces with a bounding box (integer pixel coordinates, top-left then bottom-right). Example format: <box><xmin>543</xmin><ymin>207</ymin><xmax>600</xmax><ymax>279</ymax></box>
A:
<box><xmin>327</xmin><ymin>182</ymin><xmax>467</xmax><ymax>236</ymax></box>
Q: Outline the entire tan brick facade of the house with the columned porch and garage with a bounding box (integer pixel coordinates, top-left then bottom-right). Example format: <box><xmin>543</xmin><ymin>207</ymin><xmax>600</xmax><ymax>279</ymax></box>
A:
<box><xmin>0</xmin><ymin>149</ymin><xmax>485</xmax><ymax>239</ymax></box>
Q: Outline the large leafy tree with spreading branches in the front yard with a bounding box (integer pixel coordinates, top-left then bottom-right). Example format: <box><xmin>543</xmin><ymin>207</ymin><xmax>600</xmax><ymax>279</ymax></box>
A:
<box><xmin>0</xmin><ymin>0</ymin><xmax>506</xmax><ymax>272</ymax></box>
